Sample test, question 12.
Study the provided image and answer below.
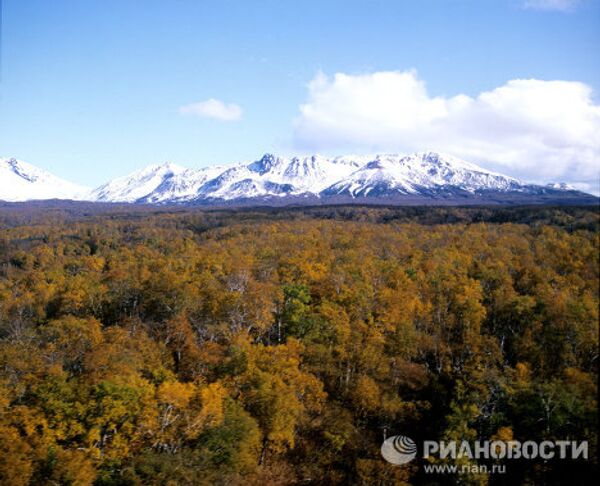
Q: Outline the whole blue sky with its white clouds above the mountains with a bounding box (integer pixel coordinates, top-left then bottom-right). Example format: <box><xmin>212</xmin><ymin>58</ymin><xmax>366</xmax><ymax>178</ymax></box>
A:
<box><xmin>0</xmin><ymin>0</ymin><xmax>600</xmax><ymax>190</ymax></box>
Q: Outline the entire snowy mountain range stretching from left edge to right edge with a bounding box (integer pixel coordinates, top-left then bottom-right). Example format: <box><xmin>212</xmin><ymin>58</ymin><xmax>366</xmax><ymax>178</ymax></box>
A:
<box><xmin>0</xmin><ymin>152</ymin><xmax>598</xmax><ymax>205</ymax></box>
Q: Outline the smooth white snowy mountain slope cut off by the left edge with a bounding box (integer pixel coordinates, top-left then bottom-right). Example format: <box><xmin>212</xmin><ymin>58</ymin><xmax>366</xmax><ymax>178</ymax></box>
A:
<box><xmin>0</xmin><ymin>157</ymin><xmax>90</xmax><ymax>201</ymax></box>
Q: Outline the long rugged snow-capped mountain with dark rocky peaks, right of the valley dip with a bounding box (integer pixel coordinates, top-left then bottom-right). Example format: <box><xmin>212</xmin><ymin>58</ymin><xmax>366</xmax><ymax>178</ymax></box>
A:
<box><xmin>86</xmin><ymin>152</ymin><xmax>584</xmax><ymax>204</ymax></box>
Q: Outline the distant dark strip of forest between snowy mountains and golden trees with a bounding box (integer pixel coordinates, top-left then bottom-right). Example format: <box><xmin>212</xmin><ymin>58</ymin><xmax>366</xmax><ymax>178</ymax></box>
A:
<box><xmin>0</xmin><ymin>201</ymin><xmax>600</xmax><ymax>231</ymax></box>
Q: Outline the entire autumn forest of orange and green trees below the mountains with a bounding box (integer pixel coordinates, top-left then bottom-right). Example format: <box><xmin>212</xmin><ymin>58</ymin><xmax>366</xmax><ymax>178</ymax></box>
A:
<box><xmin>0</xmin><ymin>205</ymin><xmax>599</xmax><ymax>485</ymax></box>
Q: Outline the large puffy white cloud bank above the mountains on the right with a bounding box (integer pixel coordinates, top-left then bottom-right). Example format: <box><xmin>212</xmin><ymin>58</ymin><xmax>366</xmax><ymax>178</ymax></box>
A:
<box><xmin>294</xmin><ymin>71</ymin><xmax>600</xmax><ymax>192</ymax></box>
